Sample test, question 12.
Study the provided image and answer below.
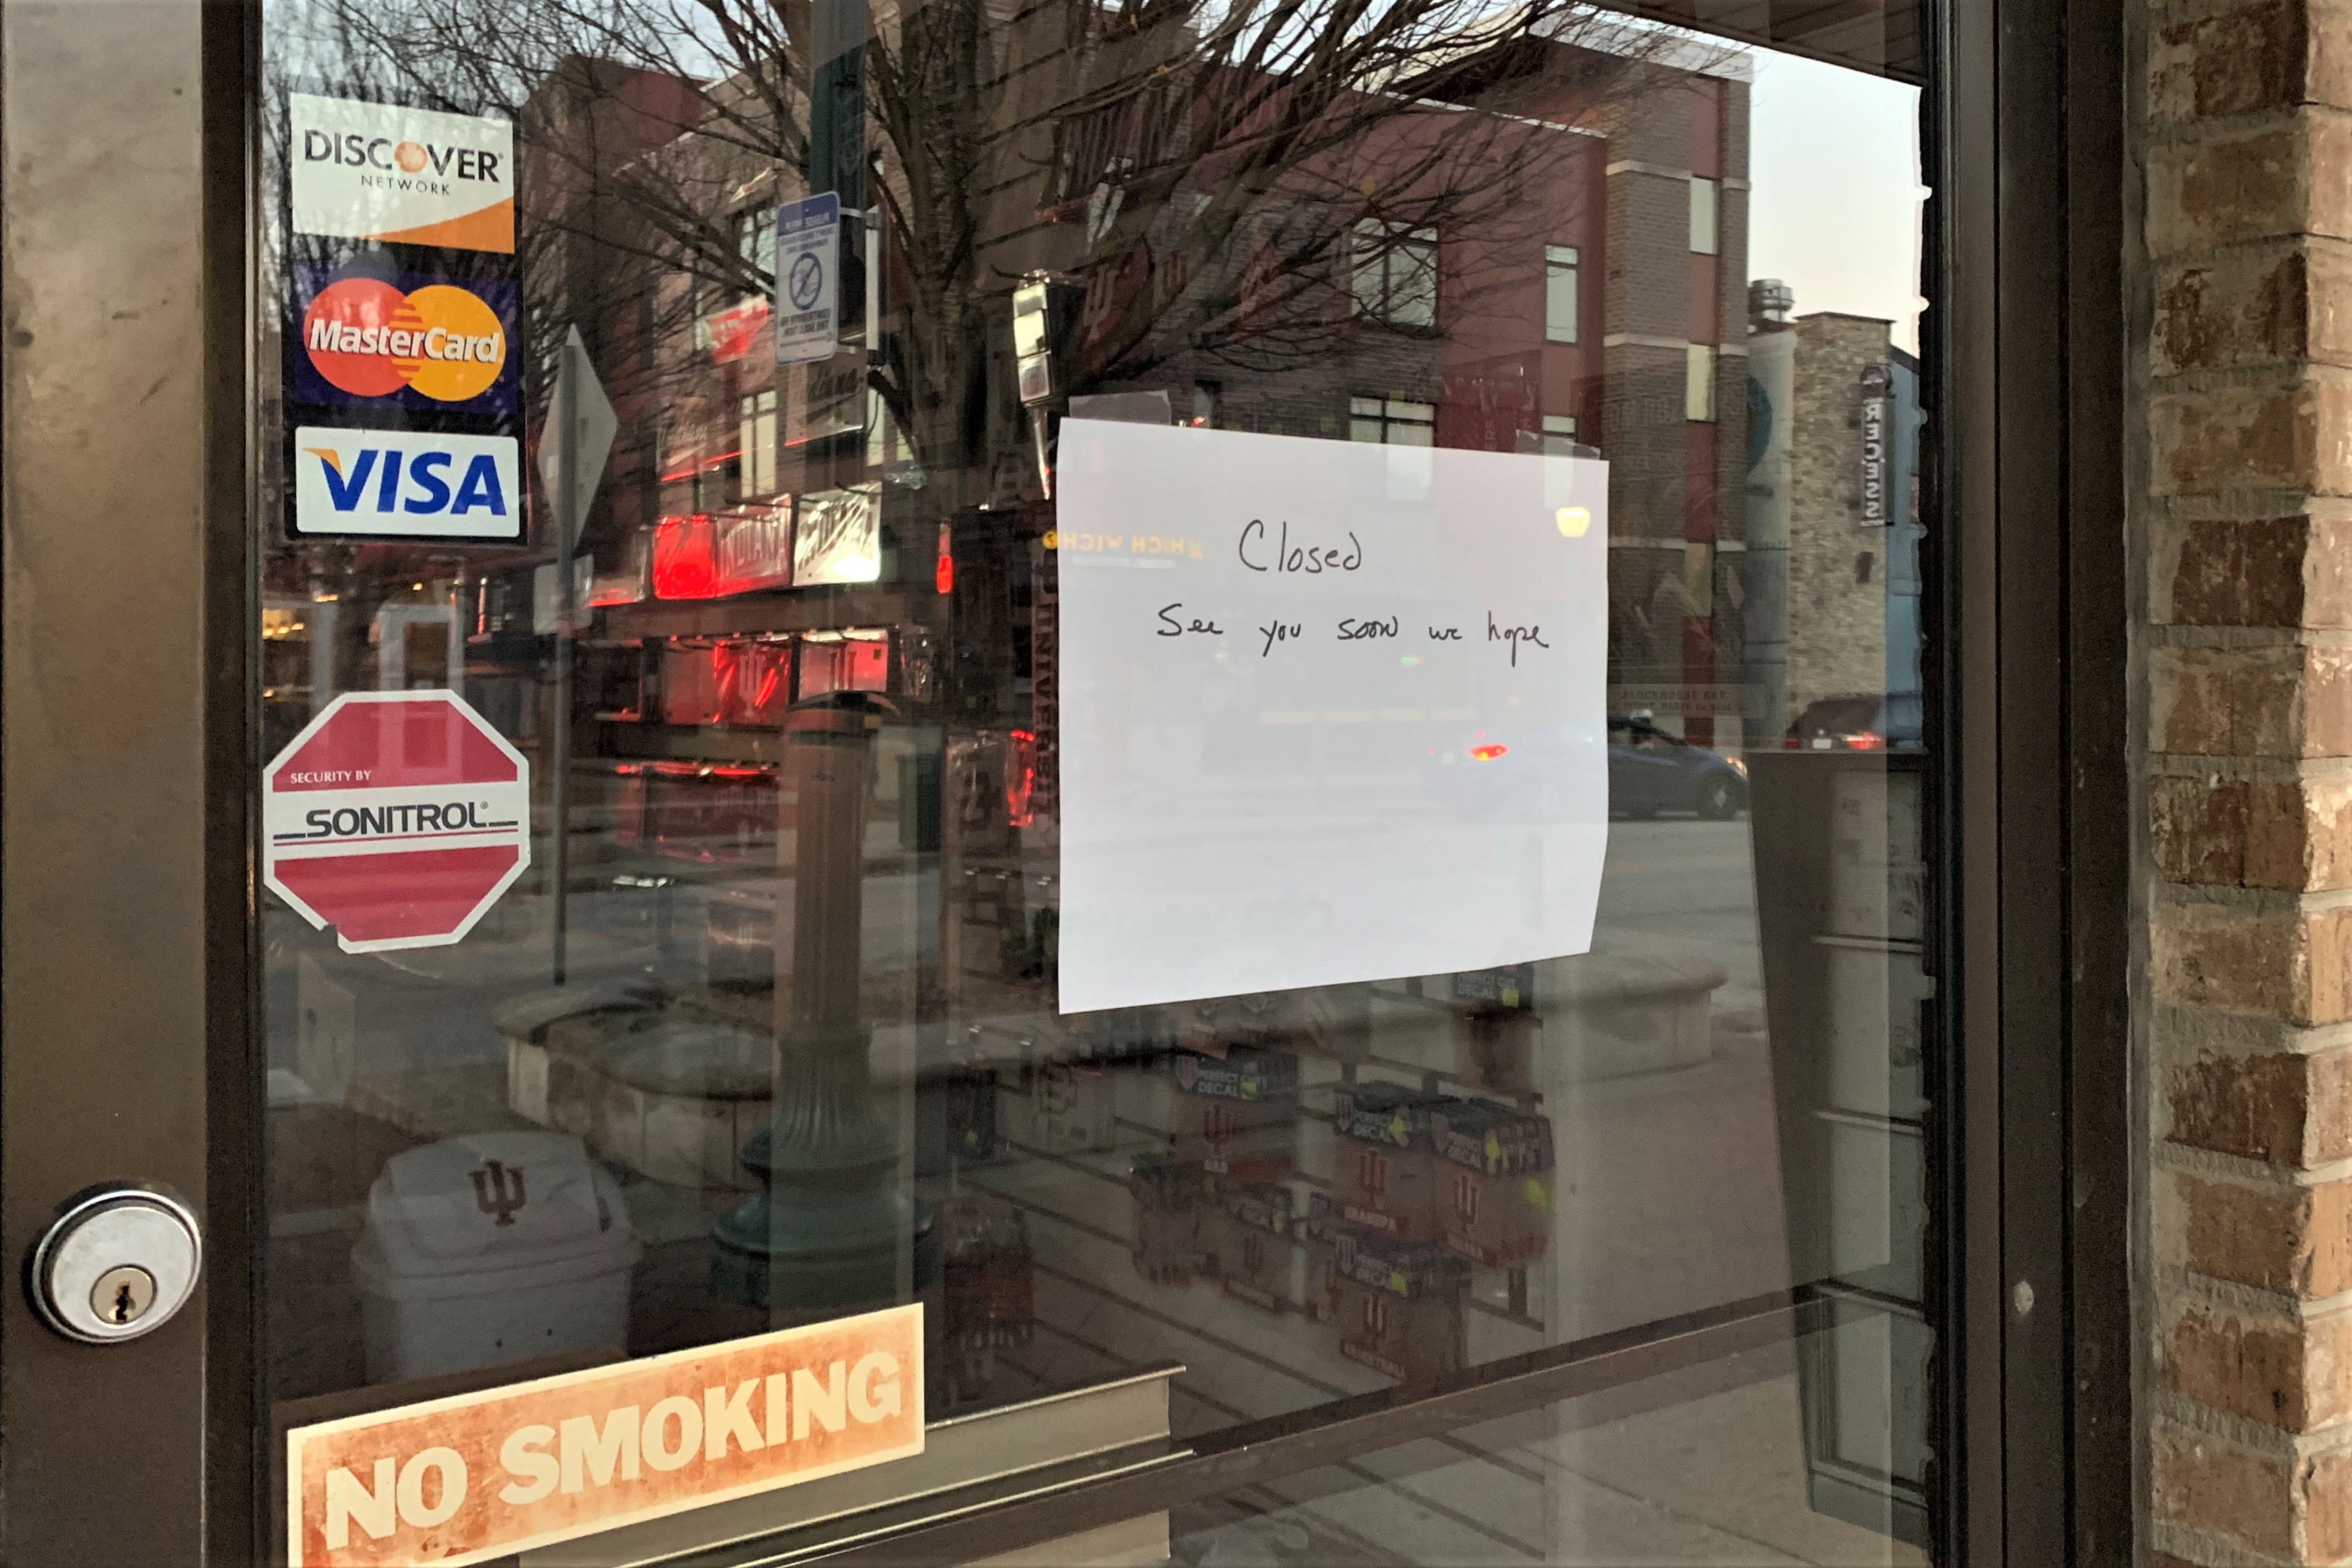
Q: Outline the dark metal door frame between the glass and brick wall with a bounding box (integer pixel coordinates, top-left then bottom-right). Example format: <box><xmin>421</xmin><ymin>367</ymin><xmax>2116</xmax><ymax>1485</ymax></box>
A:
<box><xmin>1929</xmin><ymin>0</ymin><xmax>2145</xmax><ymax>1568</ymax></box>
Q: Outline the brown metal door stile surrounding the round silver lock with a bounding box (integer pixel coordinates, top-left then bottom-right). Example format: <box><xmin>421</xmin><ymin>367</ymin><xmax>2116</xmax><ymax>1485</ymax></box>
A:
<box><xmin>0</xmin><ymin>0</ymin><xmax>259</xmax><ymax>1563</ymax></box>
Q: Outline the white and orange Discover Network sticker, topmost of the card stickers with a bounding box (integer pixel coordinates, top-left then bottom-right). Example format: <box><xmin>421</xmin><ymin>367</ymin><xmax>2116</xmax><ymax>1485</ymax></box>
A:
<box><xmin>287</xmin><ymin>92</ymin><xmax>515</xmax><ymax>256</ymax></box>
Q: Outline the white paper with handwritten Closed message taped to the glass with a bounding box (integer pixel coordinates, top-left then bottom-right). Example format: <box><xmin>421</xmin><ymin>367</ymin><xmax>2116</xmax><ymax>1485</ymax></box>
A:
<box><xmin>1054</xmin><ymin>421</ymin><xmax>1609</xmax><ymax>1013</ymax></box>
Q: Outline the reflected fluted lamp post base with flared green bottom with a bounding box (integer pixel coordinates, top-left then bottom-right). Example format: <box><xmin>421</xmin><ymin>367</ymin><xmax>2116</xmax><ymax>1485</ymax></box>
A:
<box><xmin>710</xmin><ymin>691</ymin><xmax>939</xmax><ymax>1321</ymax></box>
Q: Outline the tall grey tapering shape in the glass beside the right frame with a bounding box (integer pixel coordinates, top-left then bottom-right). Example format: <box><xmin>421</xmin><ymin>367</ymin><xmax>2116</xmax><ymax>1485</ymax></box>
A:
<box><xmin>1747</xmin><ymin>750</ymin><xmax>1936</xmax><ymax>1547</ymax></box>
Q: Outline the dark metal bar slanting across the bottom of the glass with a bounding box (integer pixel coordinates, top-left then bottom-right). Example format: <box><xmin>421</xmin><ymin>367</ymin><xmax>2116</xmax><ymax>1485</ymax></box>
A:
<box><xmin>753</xmin><ymin>1291</ymin><xmax>1816</xmax><ymax>1568</ymax></box>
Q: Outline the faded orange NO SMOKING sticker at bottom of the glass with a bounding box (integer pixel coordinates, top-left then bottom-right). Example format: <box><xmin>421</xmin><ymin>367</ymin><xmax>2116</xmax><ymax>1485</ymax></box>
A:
<box><xmin>287</xmin><ymin>1302</ymin><xmax>924</xmax><ymax>1568</ymax></box>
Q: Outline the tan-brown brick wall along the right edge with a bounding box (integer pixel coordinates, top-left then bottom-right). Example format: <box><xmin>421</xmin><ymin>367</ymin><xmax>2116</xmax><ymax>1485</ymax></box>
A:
<box><xmin>2140</xmin><ymin>0</ymin><xmax>2352</xmax><ymax>1566</ymax></box>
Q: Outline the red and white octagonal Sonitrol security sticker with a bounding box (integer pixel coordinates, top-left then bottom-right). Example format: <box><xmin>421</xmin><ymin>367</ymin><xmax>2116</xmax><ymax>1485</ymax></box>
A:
<box><xmin>261</xmin><ymin>691</ymin><xmax>531</xmax><ymax>952</ymax></box>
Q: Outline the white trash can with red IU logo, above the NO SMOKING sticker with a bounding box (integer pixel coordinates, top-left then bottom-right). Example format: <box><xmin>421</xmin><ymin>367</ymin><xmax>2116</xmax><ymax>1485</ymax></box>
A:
<box><xmin>351</xmin><ymin>1133</ymin><xmax>642</xmax><ymax>1382</ymax></box>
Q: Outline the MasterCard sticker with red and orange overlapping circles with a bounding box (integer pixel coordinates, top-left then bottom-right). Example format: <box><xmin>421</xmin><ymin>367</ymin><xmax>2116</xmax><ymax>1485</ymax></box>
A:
<box><xmin>292</xmin><ymin>273</ymin><xmax>517</xmax><ymax>414</ymax></box>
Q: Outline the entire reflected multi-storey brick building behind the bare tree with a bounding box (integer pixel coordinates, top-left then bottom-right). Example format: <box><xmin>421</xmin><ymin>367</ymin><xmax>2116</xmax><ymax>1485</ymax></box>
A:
<box><xmin>515</xmin><ymin>7</ymin><xmax>1747</xmax><ymax>766</ymax></box>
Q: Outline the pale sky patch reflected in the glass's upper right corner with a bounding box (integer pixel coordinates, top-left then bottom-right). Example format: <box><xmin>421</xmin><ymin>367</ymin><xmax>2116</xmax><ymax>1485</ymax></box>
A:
<box><xmin>1747</xmin><ymin>49</ymin><xmax>1927</xmax><ymax>353</ymax></box>
